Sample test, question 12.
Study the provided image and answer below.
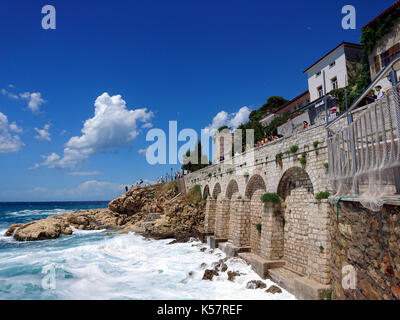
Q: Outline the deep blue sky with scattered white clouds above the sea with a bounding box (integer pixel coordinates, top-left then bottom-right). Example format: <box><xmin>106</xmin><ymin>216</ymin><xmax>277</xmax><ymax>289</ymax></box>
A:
<box><xmin>0</xmin><ymin>0</ymin><xmax>394</xmax><ymax>201</ymax></box>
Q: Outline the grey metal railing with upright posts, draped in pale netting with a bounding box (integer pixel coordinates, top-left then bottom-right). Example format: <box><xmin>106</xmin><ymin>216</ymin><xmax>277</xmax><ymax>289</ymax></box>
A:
<box><xmin>327</xmin><ymin>82</ymin><xmax>400</xmax><ymax>194</ymax></box>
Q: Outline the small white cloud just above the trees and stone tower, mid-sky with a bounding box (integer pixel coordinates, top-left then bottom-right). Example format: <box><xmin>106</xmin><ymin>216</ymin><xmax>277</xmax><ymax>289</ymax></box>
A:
<box><xmin>204</xmin><ymin>107</ymin><xmax>251</xmax><ymax>135</ymax></box>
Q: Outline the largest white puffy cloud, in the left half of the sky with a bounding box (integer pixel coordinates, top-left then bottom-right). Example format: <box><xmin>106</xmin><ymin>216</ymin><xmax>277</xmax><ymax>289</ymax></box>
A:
<box><xmin>36</xmin><ymin>93</ymin><xmax>153</xmax><ymax>168</ymax></box>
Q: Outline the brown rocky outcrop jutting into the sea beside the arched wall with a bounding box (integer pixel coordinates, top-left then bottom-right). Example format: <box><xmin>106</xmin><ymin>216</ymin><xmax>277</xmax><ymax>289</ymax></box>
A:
<box><xmin>6</xmin><ymin>181</ymin><xmax>205</xmax><ymax>242</ymax></box>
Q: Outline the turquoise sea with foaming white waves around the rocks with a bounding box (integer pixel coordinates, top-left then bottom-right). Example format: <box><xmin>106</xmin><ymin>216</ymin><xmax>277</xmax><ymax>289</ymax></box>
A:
<box><xmin>0</xmin><ymin>202</ymin><xmax>294</xmax><ymax>300</ymax></box>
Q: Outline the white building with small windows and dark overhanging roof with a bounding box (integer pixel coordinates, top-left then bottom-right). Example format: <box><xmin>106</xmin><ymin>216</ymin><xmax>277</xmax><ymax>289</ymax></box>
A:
<box><xmin>304</xmin><ymin>42</ymin><xmax>363</xmax><ymax>102</ymax></box>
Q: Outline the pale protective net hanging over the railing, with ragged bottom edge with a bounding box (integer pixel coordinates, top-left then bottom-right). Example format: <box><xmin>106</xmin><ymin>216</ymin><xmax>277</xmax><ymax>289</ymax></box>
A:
<box><xmin>328</xmin><ymin>86</ymin><xmax>400</xmax><ymax>212</ymax></box>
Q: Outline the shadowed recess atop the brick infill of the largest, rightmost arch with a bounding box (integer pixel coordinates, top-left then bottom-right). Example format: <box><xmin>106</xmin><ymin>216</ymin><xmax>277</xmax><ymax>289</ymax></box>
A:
<box><xmin>277</xmin><ymin>167</ymin><xmax>314</xmax><ymax>199</ymax></box>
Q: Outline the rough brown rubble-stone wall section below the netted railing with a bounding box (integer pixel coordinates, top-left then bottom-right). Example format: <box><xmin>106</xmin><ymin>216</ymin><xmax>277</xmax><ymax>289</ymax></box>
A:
<box><xmin>330</xmin><ymin>201</ymin><xmax>400</xmax><ymax>300</ymax></box>
